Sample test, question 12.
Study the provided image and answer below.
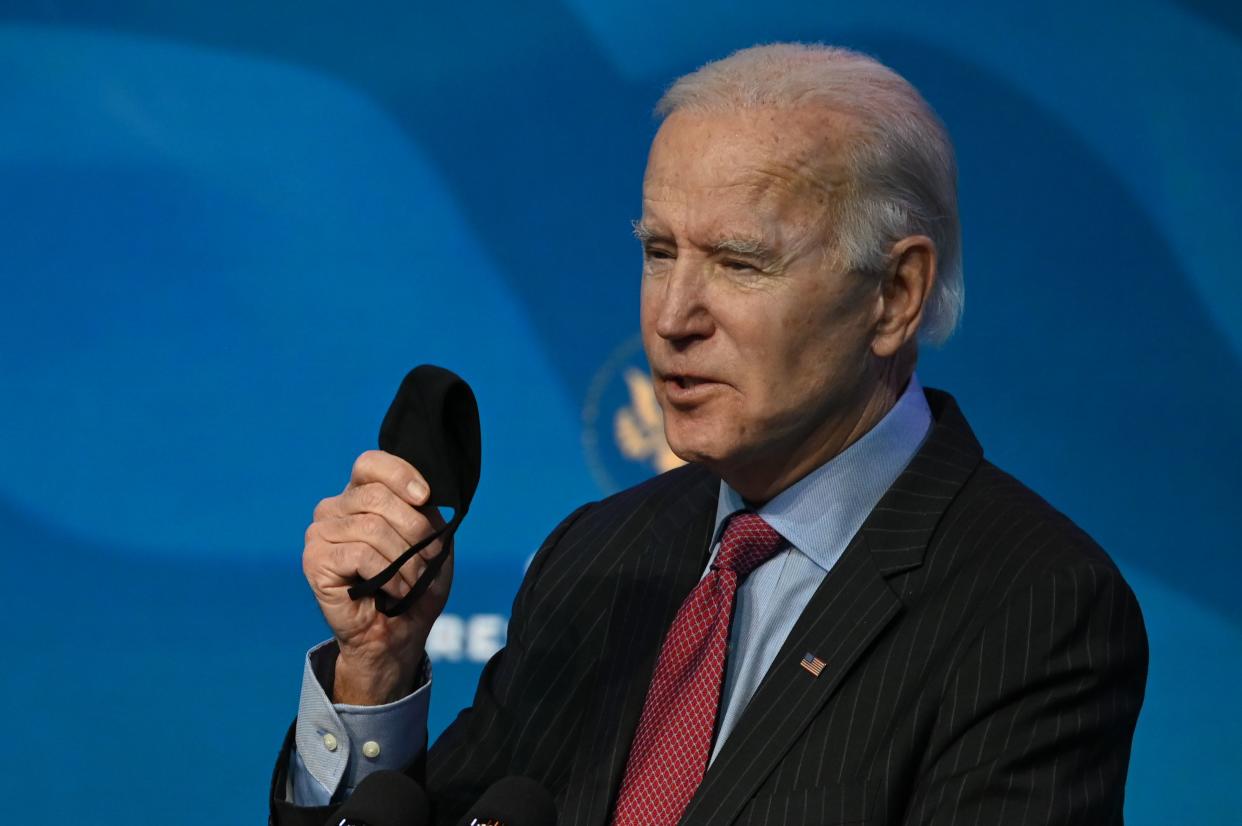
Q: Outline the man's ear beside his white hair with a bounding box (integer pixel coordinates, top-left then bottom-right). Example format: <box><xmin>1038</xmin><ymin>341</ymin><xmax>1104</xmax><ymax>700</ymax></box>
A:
<box><xmin>871</xmin><ymin>235</ymin><xmax>936</xmax><ymax>358</ymax></box>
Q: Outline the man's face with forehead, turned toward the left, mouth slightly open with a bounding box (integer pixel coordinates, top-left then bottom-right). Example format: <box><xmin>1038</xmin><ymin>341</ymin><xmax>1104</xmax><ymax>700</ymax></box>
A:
<box><xmin>638</xmin><ymin>109</ymin><xmax>878</xmax><ymax>496</ymax></box>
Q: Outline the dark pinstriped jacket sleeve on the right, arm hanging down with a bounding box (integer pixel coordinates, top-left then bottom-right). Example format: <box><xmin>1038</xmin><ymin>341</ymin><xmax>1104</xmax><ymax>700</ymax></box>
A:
<box><xmin>905</xmin><ymin>563</ymin><xmax>1148</xmax><ymax>826</ymax></box>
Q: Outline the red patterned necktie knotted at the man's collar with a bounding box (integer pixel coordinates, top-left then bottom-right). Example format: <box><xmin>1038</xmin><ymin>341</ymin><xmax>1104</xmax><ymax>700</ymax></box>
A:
<box><xmin>612</xmin><ymin>512</ymin><xmax>782</xmax><ymax>826</ymax></box>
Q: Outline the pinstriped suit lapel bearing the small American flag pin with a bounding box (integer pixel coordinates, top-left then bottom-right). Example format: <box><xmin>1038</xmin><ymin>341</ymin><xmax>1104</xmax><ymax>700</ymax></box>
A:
<box><xmin>680</xmin><ymin>390</ymin><xmax>982</xmax><ymax>824</ymax></box>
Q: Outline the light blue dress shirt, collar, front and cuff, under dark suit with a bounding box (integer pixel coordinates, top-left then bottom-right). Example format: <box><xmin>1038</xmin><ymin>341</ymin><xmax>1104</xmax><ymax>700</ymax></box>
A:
<box><xmin>289</xmin><ymin>378</ymin><xmax>932</xmax><ymax>806</ymax></box>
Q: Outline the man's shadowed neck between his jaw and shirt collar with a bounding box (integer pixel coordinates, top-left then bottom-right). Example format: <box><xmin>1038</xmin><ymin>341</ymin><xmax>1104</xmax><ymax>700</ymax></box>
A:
<box><xmin>720</xmin><ymin>358</ymin><xmax>914</xmax><ymax>507</ymax></box>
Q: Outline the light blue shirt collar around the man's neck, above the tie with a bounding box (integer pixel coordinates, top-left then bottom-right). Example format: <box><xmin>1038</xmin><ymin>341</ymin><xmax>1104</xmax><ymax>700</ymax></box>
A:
<box><xmin>712</xmin><ymin>376</ymin><xmax>932</xmax><ymax>570</ymax></box>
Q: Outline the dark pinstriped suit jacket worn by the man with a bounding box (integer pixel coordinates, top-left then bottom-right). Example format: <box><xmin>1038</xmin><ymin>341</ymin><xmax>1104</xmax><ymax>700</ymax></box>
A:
<box><xmin>273</xmin><ymin>390</ymin><xmax>1148</xmax><ymax>826</ymax></box>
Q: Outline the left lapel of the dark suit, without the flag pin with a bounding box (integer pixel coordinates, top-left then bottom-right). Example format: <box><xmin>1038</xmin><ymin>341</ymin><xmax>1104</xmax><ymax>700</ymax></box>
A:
<box><xmin>561</xmin><ymin>471</ymin><xmax>719</xmax><ymax>824</ymax></box>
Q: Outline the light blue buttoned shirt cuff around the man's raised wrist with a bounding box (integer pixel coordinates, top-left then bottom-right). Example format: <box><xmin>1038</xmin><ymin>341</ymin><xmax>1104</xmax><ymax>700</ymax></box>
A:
<box><xmin>289</xmin><ymin>641</ymin><xmax>431</xmax><ymax>806</ymax></box>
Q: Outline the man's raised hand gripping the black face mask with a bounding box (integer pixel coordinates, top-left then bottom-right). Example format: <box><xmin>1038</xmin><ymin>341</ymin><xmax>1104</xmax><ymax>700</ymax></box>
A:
<box><xmin>302</xmin><ymin>451</ymin><xmax>453</xmax><ymax>706</ymax></box>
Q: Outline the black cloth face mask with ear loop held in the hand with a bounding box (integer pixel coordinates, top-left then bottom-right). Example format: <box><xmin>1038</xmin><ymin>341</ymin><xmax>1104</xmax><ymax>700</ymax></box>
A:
<box><xmin>349</xmin><ymin>364</ymin><xmax>482</xmax><ymax>616</ymax></box>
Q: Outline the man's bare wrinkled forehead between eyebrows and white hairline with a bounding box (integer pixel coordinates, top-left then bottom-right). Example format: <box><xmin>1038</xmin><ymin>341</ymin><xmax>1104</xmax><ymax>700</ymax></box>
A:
<box><xmin>643</xmin><ymin>107</ymin><xmax>851</xmax><ymax>233</ymax></box>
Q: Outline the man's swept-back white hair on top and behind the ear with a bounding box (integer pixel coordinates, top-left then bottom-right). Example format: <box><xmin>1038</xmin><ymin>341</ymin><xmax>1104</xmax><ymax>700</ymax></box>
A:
<box><xmin>656</xmin><ymin>43</ymin><xmax>965</xmax><ymax>344</ymax></box>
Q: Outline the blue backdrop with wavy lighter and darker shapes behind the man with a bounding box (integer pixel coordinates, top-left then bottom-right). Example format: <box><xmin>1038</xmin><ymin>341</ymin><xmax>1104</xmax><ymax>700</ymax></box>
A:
<box><xmin>0</xmin><ymin>0</ymin><xmax>1242</xmax><ymax>825</ymax></box>
